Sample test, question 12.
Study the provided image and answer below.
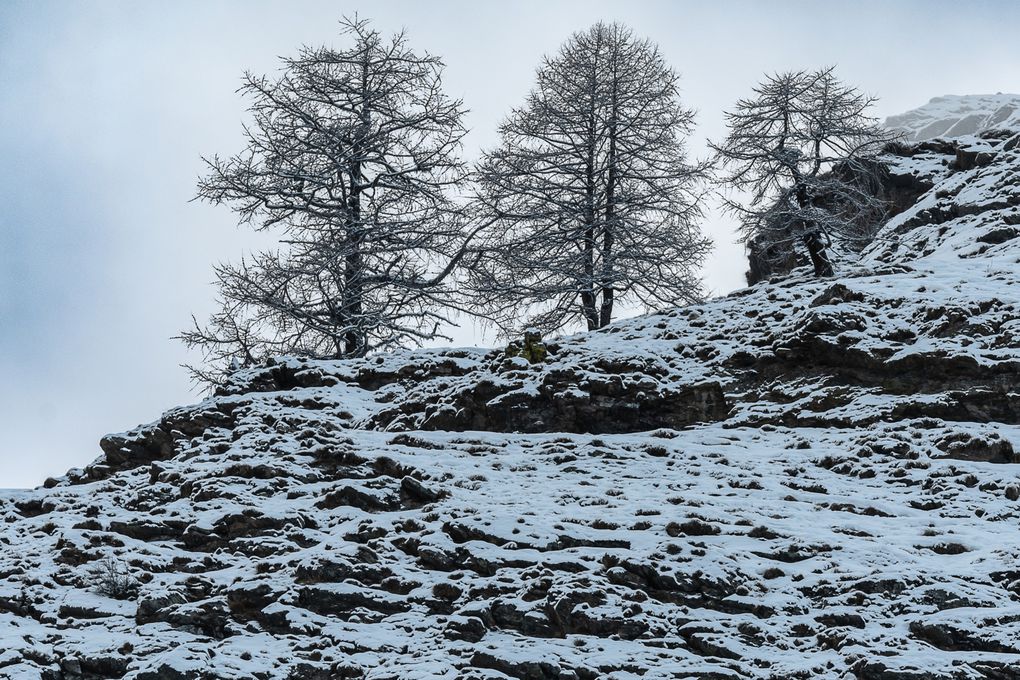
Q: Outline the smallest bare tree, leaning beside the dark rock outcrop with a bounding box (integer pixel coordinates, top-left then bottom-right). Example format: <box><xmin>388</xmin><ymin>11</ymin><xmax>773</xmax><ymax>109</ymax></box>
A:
<box><xmin>710</xmin><ymin>67</ymin><xmax>897</xmax><ymax>275</ymax></box>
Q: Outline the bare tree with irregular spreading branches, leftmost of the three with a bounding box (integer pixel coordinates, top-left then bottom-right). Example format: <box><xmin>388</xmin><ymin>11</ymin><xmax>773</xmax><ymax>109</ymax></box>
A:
<box><xmin>180</xmin><ymin>18</ymin><xmax>467</xmax><ymax>379</ymax></box>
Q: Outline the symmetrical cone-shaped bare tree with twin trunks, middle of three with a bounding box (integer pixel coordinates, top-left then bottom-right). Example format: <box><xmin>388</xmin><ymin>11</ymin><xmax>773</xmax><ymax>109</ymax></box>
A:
<box><xmin>471</xmin><ymin>23</ymin><xmax>710</xmax><ymax>332</ymax></box>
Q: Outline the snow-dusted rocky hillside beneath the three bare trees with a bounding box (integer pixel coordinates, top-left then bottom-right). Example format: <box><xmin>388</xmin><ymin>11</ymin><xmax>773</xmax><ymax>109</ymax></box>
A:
<box><xmin>0</xmin><ymin>102</ymin><xmax>1020</xmax><ymax>680</ymax></box>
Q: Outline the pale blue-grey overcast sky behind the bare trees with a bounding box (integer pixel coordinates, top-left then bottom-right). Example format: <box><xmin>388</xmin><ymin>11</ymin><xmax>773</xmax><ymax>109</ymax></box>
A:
<box><xmin>0</xmin><ymin>0</ymin><xmax>1020</xmax><ymax>487</ymax></box>
